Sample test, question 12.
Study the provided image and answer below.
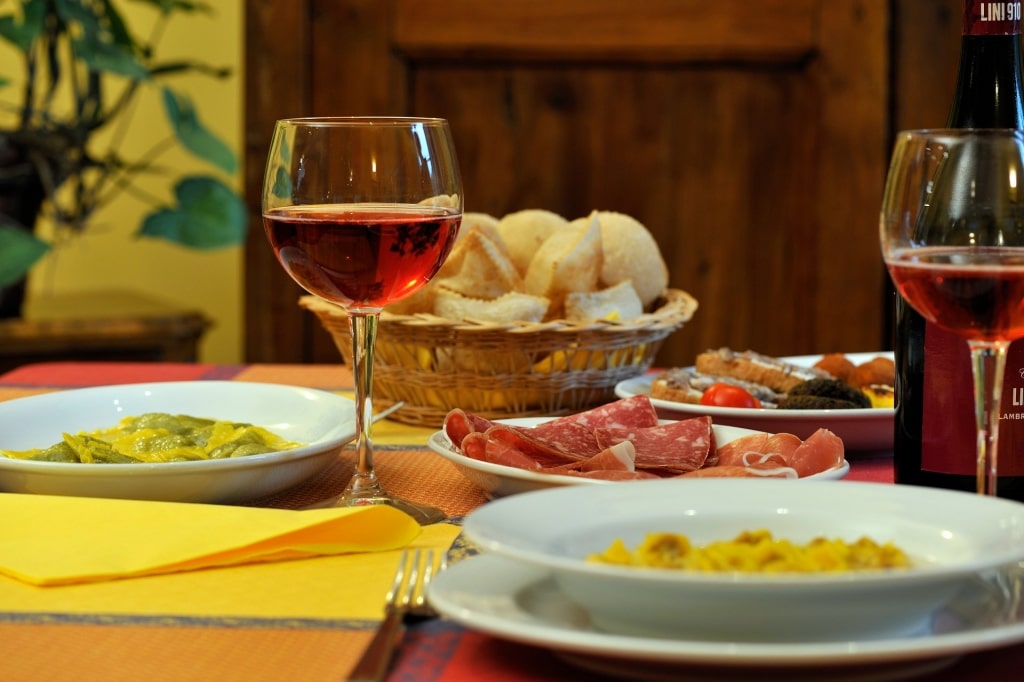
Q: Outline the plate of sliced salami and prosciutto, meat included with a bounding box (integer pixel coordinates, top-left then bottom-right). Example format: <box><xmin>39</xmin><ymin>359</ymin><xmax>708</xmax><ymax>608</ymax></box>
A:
<box><xmin>427</xmin><ymin>395</ymin><xmax>850</xmax><ymax>498</ymax></box>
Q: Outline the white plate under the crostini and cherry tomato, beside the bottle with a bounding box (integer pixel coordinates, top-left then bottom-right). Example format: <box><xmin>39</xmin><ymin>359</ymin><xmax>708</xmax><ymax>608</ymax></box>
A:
<box><xmin>615</xmin><ymin>352</ymin><xmax>896</xmax><ymax>452</ymax></box>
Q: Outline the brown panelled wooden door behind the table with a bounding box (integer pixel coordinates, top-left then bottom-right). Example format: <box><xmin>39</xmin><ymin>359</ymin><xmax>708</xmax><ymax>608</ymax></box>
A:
<box><xmin>246</xmin><ymin>0</ymin><xmax>959</xmax><ymax>365</ymax></box>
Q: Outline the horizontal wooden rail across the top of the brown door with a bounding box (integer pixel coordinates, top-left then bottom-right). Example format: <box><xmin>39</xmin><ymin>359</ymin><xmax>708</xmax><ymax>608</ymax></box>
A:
<box><xmin>392</xmin><ymin>0</ymin><xmax>818</xmax><ymax>62</ymax></box>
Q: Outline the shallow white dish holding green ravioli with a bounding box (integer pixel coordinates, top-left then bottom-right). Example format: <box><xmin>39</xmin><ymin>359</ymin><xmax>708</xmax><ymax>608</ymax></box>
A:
<box><xmin>0</xmin><ymin>381</ymin><xmax>355</xmax><ymax>503</ymax></box>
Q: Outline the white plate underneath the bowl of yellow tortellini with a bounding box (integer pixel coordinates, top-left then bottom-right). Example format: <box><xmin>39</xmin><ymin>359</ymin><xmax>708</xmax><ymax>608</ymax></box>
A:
<box><xmin>428</xmin><ymin>552</ymin><xmax>1024</xmax><ymax>682</ymax></box>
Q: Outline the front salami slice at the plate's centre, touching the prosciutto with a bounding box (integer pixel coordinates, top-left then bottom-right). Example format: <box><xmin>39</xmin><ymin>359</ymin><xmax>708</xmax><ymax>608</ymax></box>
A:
<box><xmin>596</xmin><ymin>416</ymin><xmax>715</xmax><ymax>473</ymax></box>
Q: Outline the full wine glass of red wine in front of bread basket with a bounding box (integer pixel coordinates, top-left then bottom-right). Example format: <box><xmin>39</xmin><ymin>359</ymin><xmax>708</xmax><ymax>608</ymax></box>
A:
<box><xmin>262</xmin><ymin>117</ymin><xmax>463</xmax><ymax>524</ymax></box>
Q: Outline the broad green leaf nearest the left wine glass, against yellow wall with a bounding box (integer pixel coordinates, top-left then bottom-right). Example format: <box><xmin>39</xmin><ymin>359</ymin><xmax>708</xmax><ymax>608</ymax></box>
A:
<box><xmin>138</xmin><ymin>175</ymin><xmax>249</xmax><ymax>249</ymax></box>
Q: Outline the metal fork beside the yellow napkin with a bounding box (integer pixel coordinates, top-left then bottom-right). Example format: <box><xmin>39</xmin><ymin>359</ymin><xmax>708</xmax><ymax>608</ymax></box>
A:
<box><xmin>348</xmin><ymin>550</ymin><xmax>445</xmax><ymax>682</ymax></box>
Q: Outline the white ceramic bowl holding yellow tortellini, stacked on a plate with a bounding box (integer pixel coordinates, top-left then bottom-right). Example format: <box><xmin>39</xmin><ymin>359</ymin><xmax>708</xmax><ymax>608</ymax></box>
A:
<box><xmin>464</xmin><ymin>479</ymin><xmax>1024</xmax><ymax>642</ymax></box>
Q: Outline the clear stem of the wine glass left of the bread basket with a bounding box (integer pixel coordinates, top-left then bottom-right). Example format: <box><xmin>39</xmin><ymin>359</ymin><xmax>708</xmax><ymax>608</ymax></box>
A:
<box><xmin>343</xmin><ymin>312</ymin><xmax>385</xmax><ymax>504</ymax></box>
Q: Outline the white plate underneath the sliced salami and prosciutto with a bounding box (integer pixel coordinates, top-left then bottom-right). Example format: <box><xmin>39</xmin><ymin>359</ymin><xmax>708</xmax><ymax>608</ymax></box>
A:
<box><xmin>427</xmin><ymin>417</ymin><xmax>850</xmax><ymax>498</ymax></box>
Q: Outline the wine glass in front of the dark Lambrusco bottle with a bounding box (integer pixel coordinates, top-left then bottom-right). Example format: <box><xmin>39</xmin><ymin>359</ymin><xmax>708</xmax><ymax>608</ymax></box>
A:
<box><xmin>880</xmin><ymin>129</ymin><xmax>1024</xmax><ymax>496</ymax></box>
